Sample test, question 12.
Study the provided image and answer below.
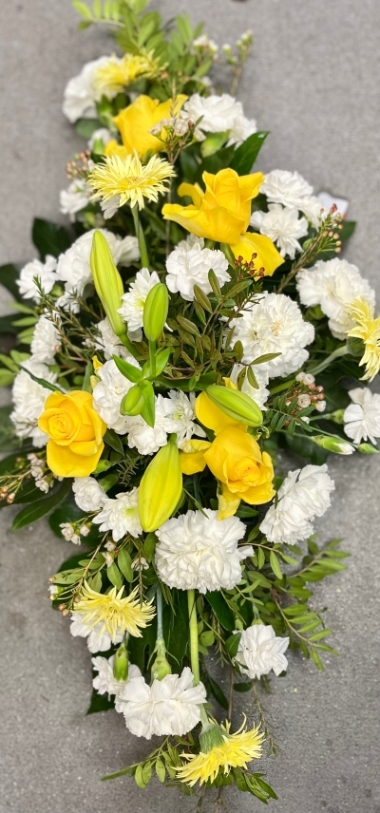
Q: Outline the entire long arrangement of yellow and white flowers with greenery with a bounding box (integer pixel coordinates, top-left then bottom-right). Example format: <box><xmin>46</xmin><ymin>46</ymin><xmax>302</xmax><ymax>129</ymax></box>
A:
<box><xmin>0</xmin><ymin>0</ymin><xmax>380</xmax><ymax>802</ymax></box>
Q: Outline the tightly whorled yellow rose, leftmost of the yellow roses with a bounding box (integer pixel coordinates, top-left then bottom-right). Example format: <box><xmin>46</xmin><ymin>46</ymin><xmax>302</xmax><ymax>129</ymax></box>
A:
<box><xmin>38</xmin><ymin>390</ymin><xmax>107</xmax><ymax>477</ymax></box>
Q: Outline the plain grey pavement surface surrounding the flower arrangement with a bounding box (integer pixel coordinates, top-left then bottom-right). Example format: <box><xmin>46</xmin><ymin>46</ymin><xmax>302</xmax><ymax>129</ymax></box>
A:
<box><xmin>0</xmin><ymin>0</ymin><xmax>380</xmax><ymax>813</ymax></box>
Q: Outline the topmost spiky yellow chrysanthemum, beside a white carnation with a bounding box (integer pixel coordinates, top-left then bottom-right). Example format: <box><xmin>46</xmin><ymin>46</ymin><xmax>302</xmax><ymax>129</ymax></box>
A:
<box><xmin>94</xmin><ymin>51</ymin><xmax>162</xmax><ymax>95</ymax></box>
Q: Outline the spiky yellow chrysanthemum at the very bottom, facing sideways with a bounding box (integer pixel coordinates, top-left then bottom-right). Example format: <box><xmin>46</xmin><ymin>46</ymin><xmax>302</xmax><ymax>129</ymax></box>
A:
<box><xmin>176</xmin><ymin>721</ymin><xmax>264</xmax><ymax>787</ymax></box>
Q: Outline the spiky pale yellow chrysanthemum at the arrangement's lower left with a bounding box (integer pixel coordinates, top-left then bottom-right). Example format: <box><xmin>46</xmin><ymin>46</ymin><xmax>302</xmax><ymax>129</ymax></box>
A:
<box><xmin>75</xmin><ymin>582</ymin><xmax>155</xmax><ymax>641</ymax></box>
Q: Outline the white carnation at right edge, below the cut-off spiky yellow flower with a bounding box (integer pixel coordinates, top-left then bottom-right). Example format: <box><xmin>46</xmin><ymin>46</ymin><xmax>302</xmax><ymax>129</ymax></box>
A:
<box><xmin>343</xmin><ymin>387</ymin><xmax>380</xmax><ymax>445</ymax></box>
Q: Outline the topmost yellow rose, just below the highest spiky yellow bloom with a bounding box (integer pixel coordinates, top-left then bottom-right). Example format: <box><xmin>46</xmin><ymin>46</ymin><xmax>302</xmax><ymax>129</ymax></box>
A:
<box><xmin>105</xmin><ymin>94</ymin><xmax>187</xmax><ymax>158</ymax></box>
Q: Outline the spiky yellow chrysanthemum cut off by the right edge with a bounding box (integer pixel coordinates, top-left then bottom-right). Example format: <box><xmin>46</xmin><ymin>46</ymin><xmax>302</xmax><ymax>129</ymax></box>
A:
<box><xmin>348</xmin><ymin>298</ymin><xmax>380</xmax><ymax>381</ymax></box>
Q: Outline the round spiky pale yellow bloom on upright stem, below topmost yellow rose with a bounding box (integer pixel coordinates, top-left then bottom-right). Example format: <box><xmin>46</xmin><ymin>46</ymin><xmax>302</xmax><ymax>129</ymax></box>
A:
<box><xmin>88</xmin><ymin>155</ymin><xmax>175</xmax><ymax>209</ymax></box>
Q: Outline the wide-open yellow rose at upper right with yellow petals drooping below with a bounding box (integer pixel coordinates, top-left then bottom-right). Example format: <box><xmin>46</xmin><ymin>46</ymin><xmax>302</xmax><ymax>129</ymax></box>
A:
<box><xmin>162</xmin><ymin>169</ymin><xmax>284</xmax><ymax>276</ymax></box>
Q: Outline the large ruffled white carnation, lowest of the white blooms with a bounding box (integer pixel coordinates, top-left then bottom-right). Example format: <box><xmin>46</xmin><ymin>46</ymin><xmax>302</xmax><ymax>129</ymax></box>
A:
<box><xmin>116</xmin><ymin>666</ymin><xmax>206</xmax><ymax>740</ymax></box>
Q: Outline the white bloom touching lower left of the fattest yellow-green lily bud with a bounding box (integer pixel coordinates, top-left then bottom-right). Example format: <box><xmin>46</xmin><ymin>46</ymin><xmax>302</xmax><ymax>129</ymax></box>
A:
<box><xmin>93</xmin><ymin>488</ymin><xmax>142</xmax><ymax>542</ymax></box>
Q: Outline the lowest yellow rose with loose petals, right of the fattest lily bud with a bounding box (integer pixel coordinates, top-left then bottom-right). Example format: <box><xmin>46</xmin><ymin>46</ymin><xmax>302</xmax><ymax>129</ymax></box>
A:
<box><xmin>181</xmin><ymin>393</ymin><xmax>275</xmax><ymax>519</ymax></box>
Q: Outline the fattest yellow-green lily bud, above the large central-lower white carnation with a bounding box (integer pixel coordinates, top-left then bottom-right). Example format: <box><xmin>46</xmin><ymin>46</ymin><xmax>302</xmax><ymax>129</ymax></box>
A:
<box><xmin>138</xmin><ymin>435</ymin><xmax>182</xmax><ymax>532</ymax></box>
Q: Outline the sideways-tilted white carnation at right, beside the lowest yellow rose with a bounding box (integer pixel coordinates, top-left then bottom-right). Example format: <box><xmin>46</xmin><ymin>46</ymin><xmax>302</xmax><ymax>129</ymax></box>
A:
<box><xmin>260</xmin><ymin>464</ymin><xmax>335</xmax><ymax>545</ymax></box>
